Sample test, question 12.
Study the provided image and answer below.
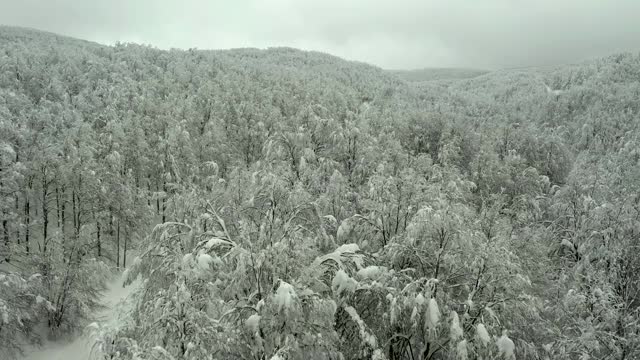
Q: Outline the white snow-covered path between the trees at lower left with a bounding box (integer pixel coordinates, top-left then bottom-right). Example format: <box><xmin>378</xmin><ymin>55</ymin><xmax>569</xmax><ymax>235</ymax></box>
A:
<box><xmin>23</xmin><ymin>276</ymin><xmax>133</xmax><ymax>360</ymax></box>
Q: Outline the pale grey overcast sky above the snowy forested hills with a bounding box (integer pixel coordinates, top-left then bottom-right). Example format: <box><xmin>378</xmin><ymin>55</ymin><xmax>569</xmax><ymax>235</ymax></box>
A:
<box><xmin>0</xmin><ymin>0</ymin><xmax>640</xmax><ymax>69</ymax></box>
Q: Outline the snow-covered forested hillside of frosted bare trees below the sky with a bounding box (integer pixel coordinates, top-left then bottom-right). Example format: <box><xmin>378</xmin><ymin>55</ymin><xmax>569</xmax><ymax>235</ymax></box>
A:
<box><xmin>0</xmin><ymin>27</ymin><xmax>640</xmax><ymax>360</ymax></box>
